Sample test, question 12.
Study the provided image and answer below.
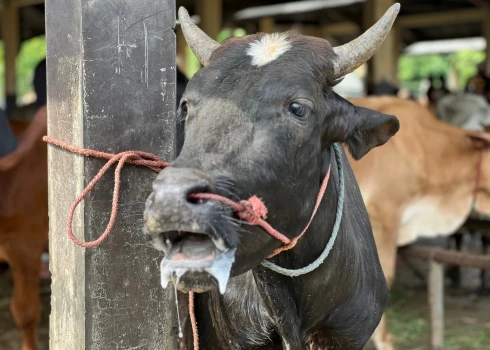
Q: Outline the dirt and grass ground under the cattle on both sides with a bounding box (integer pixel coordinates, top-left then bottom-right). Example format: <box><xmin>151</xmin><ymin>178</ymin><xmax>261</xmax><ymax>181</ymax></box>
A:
<box><xmin>0</xmin><ymin>237</ymin><xmax>490</xmax><ymax>350</ymax></box>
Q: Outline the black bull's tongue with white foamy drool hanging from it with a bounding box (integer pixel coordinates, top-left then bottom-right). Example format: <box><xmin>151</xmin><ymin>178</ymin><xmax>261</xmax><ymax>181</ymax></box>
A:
<box><xmin>160</xmin><ymin>235</ymin><xmax>235</xmax><ymax>294</ymax></box>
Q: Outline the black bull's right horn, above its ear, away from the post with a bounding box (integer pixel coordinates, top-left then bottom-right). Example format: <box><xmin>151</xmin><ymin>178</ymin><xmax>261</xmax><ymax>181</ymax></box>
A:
<box><xmin>334</xmin><ymin>3</ymin><xmax>400</xmax><ymax>79</ymax></box>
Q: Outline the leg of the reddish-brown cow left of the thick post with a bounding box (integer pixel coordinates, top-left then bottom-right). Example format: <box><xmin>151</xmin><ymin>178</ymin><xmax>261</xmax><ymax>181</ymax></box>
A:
<box><xmin>10</xmin><ymin>247</ymin><xmax>41</xmax><ymax>350</ymax></box>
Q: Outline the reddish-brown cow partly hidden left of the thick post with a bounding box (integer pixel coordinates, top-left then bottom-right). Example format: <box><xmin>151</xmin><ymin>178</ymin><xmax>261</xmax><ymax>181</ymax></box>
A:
<box><xmin>0</xmin><ymin>121</ymin><xmax>48</xmax><ymax>350</ymax></box>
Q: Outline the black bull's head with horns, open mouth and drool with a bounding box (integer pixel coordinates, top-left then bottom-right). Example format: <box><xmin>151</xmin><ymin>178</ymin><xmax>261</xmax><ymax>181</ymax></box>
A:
<box><xmin>145</xmin><ymin>4</ymin><xmax>399</xmax><ymax>291</ymax></box>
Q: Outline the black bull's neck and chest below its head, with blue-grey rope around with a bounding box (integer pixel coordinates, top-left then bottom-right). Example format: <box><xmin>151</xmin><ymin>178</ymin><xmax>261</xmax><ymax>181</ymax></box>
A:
<box><xmin>193</xmin><ymin>147</ymin><xmax>385</xmax><ymax>349</ymax></box>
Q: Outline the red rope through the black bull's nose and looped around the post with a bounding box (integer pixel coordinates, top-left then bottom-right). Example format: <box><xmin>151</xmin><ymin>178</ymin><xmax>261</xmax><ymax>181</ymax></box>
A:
<box><xmin>43</xmin><ymin>136</ymin><xmax>330</xmax><ymax>350</ymax></box>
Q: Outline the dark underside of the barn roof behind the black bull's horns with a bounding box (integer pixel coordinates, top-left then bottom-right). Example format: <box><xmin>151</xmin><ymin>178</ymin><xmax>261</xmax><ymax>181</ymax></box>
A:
<box><xmin>0</xmin><ymin>0</ymin><xmax>490</xmax><ymax>45</ymax></box>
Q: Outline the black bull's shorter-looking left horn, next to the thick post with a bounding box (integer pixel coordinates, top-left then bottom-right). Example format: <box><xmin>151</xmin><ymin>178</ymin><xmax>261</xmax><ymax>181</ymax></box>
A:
<box><xmin>179</xmin><ymin>7</ymin><xmax>219</xmax><ymax>66</ymax></box>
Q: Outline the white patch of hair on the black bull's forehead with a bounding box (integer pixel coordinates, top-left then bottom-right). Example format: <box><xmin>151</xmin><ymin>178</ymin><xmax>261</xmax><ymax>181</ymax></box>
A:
<box><xmin>247</xmin><ymin>33</ymin><xmax>291</xmax><ymax>67</ymax></box>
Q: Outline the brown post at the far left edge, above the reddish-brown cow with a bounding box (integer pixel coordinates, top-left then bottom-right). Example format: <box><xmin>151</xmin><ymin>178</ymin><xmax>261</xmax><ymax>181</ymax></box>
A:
<box><xmin>2</xmin><ymin>1</ymin><xmax>20</xmax><ymax>115</ymax></box>
